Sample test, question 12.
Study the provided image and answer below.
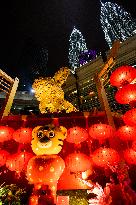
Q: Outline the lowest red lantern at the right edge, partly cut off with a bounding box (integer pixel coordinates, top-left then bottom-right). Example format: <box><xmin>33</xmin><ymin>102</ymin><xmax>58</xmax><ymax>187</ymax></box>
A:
<box><xmin>124</xmin><ymin>149</ymin><xmax>136</xmax><ymax>164</ymax></box>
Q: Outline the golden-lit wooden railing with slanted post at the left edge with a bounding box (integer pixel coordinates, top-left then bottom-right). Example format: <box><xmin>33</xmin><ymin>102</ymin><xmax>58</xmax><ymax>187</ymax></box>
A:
<box><xmin>0</xmin><ymin>69</ymin><xmax>19</xmax><ymax>120</ymax></box>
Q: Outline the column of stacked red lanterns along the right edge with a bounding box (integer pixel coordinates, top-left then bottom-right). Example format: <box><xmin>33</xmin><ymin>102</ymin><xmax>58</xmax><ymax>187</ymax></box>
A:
<box><xmin>110</xmin><ymin>66</ymin><xmax>136</xmax><ymax>164</ymax></box>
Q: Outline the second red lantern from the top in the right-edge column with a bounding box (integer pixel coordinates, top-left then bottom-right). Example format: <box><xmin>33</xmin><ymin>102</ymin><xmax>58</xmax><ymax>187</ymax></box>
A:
<box><xmin>115</xmin><ymin>84</ymin><xmax>136</xmax><ymax>104</ymax></box>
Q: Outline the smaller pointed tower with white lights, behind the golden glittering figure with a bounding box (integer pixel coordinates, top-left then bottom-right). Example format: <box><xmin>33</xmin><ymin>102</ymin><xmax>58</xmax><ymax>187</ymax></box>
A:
<box><xmin>68</xmin><ymin>27</ymin><xmax>87</xmax><ymax>73</ymax></box>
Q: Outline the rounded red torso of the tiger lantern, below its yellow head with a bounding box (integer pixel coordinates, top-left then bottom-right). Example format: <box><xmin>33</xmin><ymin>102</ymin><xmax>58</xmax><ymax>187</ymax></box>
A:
<box><xmin>27</xmin><ymin>155</ymin><xmax>65</xmax><ymax>185</ymax></box>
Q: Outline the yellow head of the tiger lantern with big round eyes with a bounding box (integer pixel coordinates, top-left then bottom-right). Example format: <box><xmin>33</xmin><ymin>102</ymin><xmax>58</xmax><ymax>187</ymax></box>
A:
<box><xmin>31</xmin><ymin>125</ymin><xmax>67</xmax><ymax>155</ymax></box>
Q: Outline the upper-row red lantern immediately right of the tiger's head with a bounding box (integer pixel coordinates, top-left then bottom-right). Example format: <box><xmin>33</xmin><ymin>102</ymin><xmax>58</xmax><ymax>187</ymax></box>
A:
<box><xmin>66</xmin><ymin>126</ymin><xmax>88</xmax><ymax>144</ymax></box>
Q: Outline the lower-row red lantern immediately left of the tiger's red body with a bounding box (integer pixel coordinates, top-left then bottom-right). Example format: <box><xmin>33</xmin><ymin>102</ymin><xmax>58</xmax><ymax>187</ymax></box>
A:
<box><xmin>6</xmin><ymin>152</ymin><xmax>33</xmax><ymax>172</ymax></box>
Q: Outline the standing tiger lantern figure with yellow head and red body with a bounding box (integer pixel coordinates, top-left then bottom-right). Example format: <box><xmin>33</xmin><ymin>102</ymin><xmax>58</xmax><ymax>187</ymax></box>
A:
<box><xmin>27</xmin><ymin>124</ymin><xmax>67</xmax><ymax>205</ymax></box>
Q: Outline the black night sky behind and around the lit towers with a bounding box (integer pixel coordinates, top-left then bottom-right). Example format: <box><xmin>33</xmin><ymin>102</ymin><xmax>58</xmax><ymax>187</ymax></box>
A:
<box><xmin>0</xmin><ymin>0</ymin><xmax>136</xmax><ymax>89</ymax></box>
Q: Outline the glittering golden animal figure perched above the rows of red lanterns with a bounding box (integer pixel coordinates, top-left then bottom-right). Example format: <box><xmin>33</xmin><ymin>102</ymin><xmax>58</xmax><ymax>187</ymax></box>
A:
<box><xmin>32</xmin><ymin>67</ymin><xmax>77</xmax><ymax>114</ymax></box>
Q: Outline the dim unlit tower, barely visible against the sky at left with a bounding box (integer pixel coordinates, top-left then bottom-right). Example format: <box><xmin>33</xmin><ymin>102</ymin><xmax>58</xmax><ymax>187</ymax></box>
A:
<box><xmin>20</xmin><ymin>39</ymin><xmax>48</xmax><ymax>83</ymax></box>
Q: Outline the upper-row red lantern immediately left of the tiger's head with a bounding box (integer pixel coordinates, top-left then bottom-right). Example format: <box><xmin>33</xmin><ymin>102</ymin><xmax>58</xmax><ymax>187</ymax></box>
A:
<box><xmin>13</xmin><ymin>127</ymin><xmax>32</xmax><ymax>143</ymax></box>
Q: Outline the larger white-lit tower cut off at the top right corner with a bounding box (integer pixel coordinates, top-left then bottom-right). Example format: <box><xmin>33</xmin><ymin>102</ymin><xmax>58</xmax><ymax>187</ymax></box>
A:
<box><xmin>100</xmin><ymin>2</ymin><xmax>136</xmax><ymax>48</ymax></box>
